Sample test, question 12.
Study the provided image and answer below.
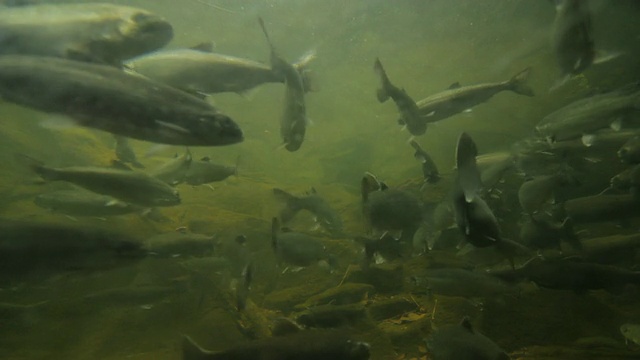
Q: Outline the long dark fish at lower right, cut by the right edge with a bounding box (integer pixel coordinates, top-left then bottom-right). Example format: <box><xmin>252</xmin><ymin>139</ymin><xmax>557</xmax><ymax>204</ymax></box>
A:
<box><xmin>493</xmin><ymin>257</ymin><xmax>640</xmax><ymax>294</ymax></box>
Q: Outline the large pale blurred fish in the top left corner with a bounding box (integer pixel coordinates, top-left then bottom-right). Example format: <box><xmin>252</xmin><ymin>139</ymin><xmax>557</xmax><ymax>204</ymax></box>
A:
<box><xmin>0</xmin><ymin>4</ymin><xmax>173</xmax><ymax>67</ymax></box>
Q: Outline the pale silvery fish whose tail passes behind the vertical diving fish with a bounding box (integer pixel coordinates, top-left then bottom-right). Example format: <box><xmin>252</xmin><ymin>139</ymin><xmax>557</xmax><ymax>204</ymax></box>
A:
<box><xmin>124</xmin><ymin>41</ymin><xmax>313</xmax><ymax>96</ymax></box>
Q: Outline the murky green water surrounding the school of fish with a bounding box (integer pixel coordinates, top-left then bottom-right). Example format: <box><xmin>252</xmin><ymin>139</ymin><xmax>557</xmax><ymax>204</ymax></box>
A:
<box><xmin>0</xmin><ymin>0</ymin><xmax>640</xmax><ymax>360</ymax></box>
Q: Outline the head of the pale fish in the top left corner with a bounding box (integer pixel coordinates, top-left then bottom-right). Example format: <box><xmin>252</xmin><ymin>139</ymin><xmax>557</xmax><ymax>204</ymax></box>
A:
<box><xmin>98</xmin><ymin>6</ymin><xmax>173</xmax><ymax>62</ymax></box>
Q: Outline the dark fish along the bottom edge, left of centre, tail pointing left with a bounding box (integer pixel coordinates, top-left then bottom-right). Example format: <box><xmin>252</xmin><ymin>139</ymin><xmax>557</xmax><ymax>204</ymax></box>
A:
<box><xmin>182</xmin><ymin>329</ymin><xmax>370</xmax><ymax>360</ymax></box>
